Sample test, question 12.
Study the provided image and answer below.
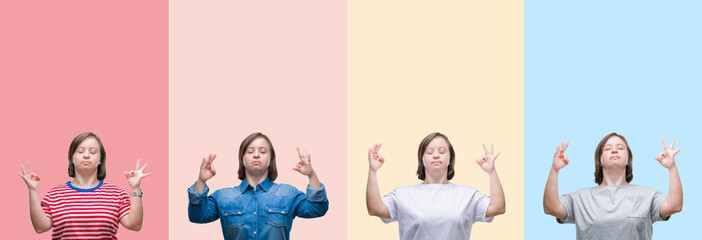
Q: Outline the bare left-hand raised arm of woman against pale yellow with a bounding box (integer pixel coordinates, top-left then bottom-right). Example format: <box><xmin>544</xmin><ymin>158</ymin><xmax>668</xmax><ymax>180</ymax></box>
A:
<box><xmin>366</xmin><ymin>144</ymin><xmax>390</xmax><ymax>218</ymax></box>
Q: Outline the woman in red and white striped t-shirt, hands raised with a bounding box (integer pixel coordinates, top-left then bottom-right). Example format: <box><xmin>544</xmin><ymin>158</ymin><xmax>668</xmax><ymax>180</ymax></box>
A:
<box><xmin>19</xmin><ymin>132</ymin><xmax>150</xmax><ymax>239</ymax></box>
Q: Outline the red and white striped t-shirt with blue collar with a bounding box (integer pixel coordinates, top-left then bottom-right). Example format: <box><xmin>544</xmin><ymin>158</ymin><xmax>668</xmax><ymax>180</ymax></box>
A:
<box><xmin>41</xmin><ymin>181</ymin><xmax>131</xmax><ymax>239</ymax></box>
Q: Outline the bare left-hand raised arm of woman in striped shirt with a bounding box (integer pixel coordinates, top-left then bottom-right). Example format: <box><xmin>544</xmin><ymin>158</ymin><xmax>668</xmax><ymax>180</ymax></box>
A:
<box><xmin>18</xmin><ymin>163</ymin><xmax>53</xmax><ymax>233</ymax></box>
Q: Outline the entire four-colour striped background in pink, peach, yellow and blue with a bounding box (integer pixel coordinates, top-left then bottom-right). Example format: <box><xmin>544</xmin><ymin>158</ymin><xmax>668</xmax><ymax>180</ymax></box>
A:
<box><xmin>0</xmin><ymin>0</ymin><xmax>702</xmax><ymax>239</ymax></box>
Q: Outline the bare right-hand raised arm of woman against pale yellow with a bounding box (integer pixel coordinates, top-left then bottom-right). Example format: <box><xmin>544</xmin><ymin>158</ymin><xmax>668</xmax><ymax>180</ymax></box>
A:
<box><xmin>475</xmin><ymin>144</ymin><xmax>506</xmax><ymax>217</ymax></box>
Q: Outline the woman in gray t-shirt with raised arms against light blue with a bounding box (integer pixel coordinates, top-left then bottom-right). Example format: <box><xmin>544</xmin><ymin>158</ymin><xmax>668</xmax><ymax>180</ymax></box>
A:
<box><xmin>544</xmin><ymin>133</ymin><xmax>683</xmax><ymax>239</ymax></box>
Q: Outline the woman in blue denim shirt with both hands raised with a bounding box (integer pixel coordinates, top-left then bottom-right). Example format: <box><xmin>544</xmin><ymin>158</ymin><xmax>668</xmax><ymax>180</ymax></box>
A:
<box><xmin>188</xmin><ymin>132</ymin><xmax>329</xmax><ymax>240</ymax></box>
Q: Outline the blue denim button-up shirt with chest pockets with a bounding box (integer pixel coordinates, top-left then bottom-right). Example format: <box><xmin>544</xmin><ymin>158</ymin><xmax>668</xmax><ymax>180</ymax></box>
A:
<box><xmin>188</xmin><ymin>178</ymin><xmax>329</xmax><ymax>240</ymax></box>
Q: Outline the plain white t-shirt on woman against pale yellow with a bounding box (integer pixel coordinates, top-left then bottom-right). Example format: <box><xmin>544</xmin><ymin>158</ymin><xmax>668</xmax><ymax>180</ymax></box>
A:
<box><xmin>381</xmin><ymin>183</ymin><xmax>493</xmax><ymax>240</ymax></box>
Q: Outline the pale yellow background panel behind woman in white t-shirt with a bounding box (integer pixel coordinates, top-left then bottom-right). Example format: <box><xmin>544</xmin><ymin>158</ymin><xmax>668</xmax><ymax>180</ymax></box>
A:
<box><xmin>348</xmin><ymin>1</ymin><xmax>524</xmax><ymax>239</ymax></box>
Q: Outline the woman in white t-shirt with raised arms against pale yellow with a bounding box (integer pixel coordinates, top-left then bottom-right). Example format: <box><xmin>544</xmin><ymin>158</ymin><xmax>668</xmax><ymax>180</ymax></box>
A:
<box><xmin>366</xmin><ymin>132</ymin><xmax>505</xmax><ymax>240</ymax></box>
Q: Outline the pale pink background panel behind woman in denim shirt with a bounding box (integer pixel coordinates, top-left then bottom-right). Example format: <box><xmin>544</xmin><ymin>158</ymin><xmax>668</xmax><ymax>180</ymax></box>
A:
<box><xmin>169</xmin><ymin>1</ymin><xmax>347</xmax><ymax>239</ymax></box>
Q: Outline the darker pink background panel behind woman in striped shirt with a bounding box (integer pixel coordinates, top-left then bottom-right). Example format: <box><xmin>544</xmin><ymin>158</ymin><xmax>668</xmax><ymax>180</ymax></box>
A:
<box><xmin>0</xmin><ymin>1</ymin><xmax>168</xmax><ymax>239</ymax></box>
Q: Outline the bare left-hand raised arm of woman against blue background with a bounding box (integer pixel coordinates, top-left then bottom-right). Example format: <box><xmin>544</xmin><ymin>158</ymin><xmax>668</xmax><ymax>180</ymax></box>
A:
<box><xmin>544</xmin><ymin>142</ymin><xmax>570</xmax><ymax>218</ymax></box>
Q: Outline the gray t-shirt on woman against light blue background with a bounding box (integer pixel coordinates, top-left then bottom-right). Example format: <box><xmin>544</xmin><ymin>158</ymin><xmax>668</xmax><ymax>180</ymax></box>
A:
<box><xmin>556</xmin><ymin>184</ymin><xmax>670</xmax><ymax>239</ymax></box>
